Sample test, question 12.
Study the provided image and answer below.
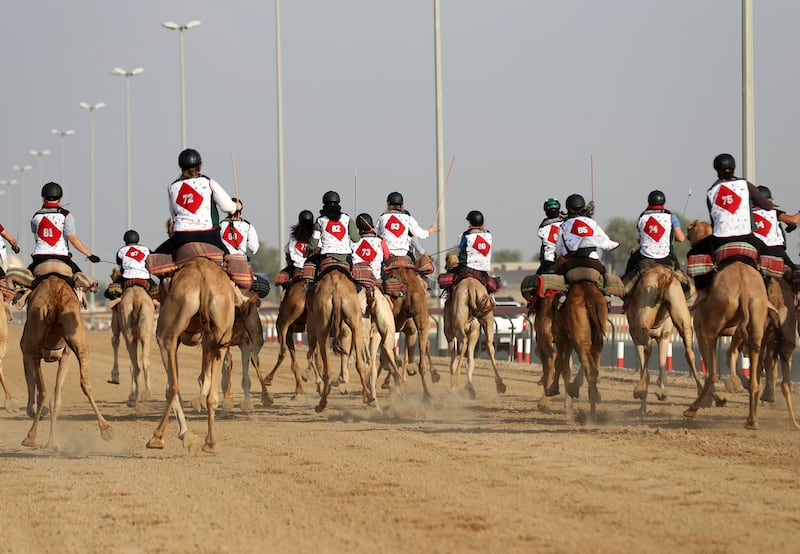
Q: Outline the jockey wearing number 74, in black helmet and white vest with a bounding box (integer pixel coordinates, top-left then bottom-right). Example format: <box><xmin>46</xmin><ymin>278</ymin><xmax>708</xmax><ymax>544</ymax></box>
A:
<box><xmin>622</xmin><ymin>190</ymin><xmax>686</xmax><ymax>283</ymax></box>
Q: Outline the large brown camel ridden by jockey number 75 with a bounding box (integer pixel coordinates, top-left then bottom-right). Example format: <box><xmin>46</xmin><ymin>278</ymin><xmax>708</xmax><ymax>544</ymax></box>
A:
<box><xmin>683</xmin><ymin>221</ymin><xmax>769</xmax><ymax>430</ymax></box>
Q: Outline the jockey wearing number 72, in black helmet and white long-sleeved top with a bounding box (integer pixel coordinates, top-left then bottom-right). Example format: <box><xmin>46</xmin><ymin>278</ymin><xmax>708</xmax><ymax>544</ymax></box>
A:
<box><xmin>155</xmin><ymin>148</ymin><xmax>237</xmax><ymax>256</ymax></box>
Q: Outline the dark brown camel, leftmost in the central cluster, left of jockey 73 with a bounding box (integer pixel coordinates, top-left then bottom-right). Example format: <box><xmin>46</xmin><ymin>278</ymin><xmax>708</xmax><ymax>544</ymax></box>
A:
<box><xmin>264</xmin><ymin>280</ymin><xmax>318</xmax><ymax>396</ymax></box>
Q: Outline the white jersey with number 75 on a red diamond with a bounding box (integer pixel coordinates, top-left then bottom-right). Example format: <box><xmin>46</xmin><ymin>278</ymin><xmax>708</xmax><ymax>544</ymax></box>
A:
<box><xmin>707</xmin><ymin>179</ymin><xmax>753</xmax><ymax>237</ymax></box>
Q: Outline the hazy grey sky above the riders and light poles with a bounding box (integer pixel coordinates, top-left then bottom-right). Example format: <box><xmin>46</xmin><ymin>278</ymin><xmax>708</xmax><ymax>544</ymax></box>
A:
<box><xmin>0</xmin><ymin>0</ymin><xmax>800</xmax><ymax>266</ymax></box>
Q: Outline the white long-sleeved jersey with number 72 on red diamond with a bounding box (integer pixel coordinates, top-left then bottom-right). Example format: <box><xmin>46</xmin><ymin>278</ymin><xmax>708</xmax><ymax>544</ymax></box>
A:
<box><xmin>167</xmin><ymin>175</ymin><xmax>236</xmax><ymax>232</ymax></box>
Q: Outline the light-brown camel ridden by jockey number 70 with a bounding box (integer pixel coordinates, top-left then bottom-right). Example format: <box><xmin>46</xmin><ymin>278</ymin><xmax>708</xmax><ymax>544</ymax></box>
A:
<box><xmin>444</xmin><ymin>254</ymin><xmax>506</xmax><ymax>399</ymax></box>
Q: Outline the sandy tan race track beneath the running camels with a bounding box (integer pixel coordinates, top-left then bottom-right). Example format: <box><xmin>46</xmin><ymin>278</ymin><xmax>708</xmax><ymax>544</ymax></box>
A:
<box><xmin>0</xmin><ymin>320</ymin><xmax>800</xmax><ymax>553</ymax></box>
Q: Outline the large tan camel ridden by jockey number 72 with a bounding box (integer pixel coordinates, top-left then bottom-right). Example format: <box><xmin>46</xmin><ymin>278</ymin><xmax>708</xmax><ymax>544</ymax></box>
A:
<box><xmin>147</xmin><ymin>258</ymin><xmax>236</xmax><ymax>452</ymax></box>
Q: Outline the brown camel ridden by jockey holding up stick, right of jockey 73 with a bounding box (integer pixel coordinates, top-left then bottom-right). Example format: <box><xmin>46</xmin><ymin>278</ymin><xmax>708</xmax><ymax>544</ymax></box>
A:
<box><xmin>391</xmin><ymin>268</ymin><xmax>439</xmax><ymax>399</ymax></box>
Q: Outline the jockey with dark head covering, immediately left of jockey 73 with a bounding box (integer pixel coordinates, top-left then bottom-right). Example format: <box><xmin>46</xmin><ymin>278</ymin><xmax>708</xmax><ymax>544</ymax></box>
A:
<box><xmin>306</xmin><ymin>190</ymin><xmax>359</xmax><ymax>265</ymax></box>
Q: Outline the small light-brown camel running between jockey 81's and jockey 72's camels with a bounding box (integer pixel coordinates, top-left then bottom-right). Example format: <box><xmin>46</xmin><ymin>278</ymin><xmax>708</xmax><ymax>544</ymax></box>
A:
<box><xmin>113</xmin><ymin>285</ymin><xmax>156</xmax><ymax>411</ymax></box>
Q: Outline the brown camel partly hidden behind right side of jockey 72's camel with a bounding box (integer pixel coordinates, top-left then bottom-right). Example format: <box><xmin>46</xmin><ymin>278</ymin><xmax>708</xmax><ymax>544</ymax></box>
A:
<box><xmin>222</xmin><ymin>294</ymin><xmax>272</xmax><ymax>414</ymax></box>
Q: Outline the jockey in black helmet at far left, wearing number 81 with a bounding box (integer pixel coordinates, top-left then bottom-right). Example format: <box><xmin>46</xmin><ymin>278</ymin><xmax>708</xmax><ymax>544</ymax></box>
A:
<box><xmin>28</xmin><ymin>181</ymin><xmax>100</xmax><ymax>274</ymax></box>
